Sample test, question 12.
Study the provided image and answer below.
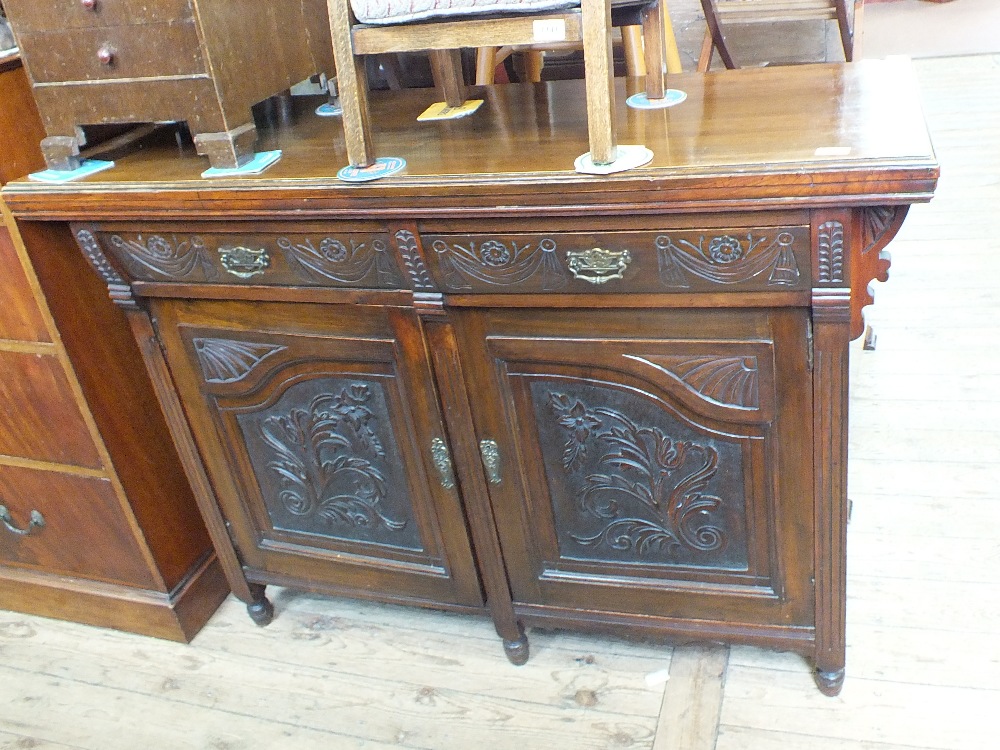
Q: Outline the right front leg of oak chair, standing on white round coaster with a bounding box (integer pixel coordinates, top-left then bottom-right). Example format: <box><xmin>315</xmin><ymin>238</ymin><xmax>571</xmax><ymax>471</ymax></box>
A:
<box><xmin>581</xmin><ymin>0</ymin><xmax>618</xmax><ymax>164</ymax></box>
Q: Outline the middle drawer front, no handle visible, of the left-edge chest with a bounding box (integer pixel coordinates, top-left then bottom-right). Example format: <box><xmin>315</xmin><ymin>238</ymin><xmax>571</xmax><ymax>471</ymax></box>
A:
<box><xmin>0</xmin><ymin>351</ymin><xmax>102</xmax><ymax>469</ymax></box>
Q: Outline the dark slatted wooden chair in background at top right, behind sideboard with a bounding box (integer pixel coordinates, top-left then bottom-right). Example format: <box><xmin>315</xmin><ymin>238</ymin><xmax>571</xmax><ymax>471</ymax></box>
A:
<box><xmin>698</xmin><ymin>0</ymin><xmax>863</xmax><ymax>72</ymax></box>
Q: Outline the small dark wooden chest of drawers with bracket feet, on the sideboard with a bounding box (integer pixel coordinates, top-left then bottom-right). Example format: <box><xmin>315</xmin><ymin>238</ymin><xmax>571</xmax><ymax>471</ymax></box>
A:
<box><xmin>4</xmin><ymin>0</ymin><xmax>333</xmax><ymax>169</ymax></box>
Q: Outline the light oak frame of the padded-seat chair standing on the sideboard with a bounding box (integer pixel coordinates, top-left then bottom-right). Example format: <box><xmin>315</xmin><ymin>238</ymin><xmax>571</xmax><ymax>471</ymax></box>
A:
<box><xmin>327</xmin><ymin>0</ymin><xmax>617</xmax><ymax>167</ymax></box>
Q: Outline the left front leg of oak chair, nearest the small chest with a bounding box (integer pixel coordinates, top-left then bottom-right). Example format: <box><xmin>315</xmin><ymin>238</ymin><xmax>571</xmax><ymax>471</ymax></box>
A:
<box><xmin>327</xmin><ymin>0</ymin><xmax>375</xmax><ymax>167</ymax></box>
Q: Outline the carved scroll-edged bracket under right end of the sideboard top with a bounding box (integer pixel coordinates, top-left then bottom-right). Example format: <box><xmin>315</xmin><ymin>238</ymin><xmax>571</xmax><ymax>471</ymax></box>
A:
<box><xmin>851</xmin><ymin>205</ymin><xmax>910</xmax><ymax>339</ymax></box>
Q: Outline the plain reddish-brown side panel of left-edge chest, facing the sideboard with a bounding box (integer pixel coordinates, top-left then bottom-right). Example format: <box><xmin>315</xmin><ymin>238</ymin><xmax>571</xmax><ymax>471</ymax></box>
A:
<box><xmin>19</xmin><ymin>223</ymin><xmax>211</xmax><ymax>589</ymax></box>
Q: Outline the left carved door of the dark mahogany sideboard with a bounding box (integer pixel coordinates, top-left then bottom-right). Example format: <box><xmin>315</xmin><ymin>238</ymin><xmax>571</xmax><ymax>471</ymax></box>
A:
<box><xmin>152</xmin><ymin>300</ymin><xmax>482</xmax><ymax>606</ymax></box>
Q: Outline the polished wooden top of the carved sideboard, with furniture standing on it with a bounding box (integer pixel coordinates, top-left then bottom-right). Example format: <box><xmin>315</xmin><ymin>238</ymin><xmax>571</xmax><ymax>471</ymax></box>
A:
<box><xmin>4</xmin><ymin>59</ymin><xmax>938</xmax><ymax>219</ymax></box>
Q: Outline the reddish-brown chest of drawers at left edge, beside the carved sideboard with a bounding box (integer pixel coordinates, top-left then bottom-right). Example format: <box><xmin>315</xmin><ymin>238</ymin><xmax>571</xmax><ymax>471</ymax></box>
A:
<box><xmin>0</xmin><ymin>56</ymin><xmax>228</xmax><ymax>640</ymax></box>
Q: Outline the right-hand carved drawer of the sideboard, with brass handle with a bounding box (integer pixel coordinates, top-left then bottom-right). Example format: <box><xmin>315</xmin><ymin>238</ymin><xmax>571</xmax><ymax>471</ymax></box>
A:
<box><xmin>422</xmin><ymin>226</ymin><xmax>810</xmax><ymax>294</ymax></box>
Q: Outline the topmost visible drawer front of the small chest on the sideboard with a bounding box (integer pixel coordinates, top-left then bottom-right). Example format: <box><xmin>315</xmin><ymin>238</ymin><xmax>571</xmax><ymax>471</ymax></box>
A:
<box><xmin>4</xmin><ymin>0</ymin><xmax>193</xmax><ymax>31</ymax></box>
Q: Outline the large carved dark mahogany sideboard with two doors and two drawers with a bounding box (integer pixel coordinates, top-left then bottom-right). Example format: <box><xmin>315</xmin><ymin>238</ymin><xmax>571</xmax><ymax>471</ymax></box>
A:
<box><xmin>6</xmin><ymin>62</ymin><xmax>937</xmax><ymax>694</ymax></box>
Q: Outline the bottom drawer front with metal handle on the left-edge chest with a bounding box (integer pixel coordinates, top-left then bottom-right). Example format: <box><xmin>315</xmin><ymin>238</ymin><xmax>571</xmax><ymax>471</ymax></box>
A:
<box><xmin>0</xmin><ymin>466</ymin><xmax>162</xmax><ymax>589</ymax></box>
